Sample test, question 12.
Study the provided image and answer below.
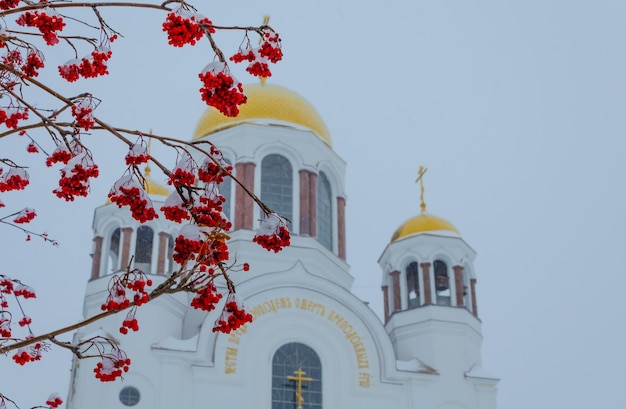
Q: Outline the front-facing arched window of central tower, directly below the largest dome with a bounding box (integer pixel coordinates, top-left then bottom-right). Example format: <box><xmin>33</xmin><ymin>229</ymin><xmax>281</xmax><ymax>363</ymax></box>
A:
<box><xmin>261</xmin><ymin>155</ymin><xmax>293</xmax><ymax>225</ymax></box>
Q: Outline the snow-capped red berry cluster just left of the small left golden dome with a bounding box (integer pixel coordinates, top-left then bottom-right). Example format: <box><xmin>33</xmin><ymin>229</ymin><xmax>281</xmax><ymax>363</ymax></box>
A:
<box><xmin>109</xmin><ymin>175</ymin><xmax>159</xmax><ymax>223</ymax></box>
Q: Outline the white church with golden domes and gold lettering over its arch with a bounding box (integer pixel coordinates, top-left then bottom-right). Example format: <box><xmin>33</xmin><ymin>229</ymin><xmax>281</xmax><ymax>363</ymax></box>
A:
<box><xmin>67</xmin><ymin>82</ymin><xmax>498</xmax><ymax>409</ymax></box>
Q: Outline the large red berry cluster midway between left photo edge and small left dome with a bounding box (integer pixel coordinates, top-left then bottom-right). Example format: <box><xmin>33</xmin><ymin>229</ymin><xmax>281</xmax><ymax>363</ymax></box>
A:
<box><xmin>52</xmin><ymin>148</ymin><xmax>99</xmax><ymax>202</ymax></box>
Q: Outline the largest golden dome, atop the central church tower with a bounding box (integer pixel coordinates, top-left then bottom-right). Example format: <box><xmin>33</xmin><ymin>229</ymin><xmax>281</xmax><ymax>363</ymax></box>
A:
<box><xmin>193</xmin><ymin>84</ymin><xmax>332</xmax><ymax>147</ymax></box>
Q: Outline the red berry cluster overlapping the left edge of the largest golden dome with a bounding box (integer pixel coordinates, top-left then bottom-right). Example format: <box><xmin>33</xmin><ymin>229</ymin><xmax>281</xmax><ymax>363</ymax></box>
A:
<box><xmin>198</xmin><ymin>62</ymin><xmax>248</xmax><ymax>117</ymax></box>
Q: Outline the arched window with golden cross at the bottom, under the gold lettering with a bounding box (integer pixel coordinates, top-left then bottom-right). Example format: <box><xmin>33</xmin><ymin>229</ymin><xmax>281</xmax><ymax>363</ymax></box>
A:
<box><xmin>272</xmin><ymin>342</ymin><xmax>322</xmax><ymax>409</ymax></box>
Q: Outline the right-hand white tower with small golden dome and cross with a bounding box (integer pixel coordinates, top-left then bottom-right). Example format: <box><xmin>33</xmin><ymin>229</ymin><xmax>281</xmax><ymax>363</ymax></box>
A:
<box><xmin>379</xmin><ymin>167</ymin><xmax>498</xmax><ymax>408</ymax></box>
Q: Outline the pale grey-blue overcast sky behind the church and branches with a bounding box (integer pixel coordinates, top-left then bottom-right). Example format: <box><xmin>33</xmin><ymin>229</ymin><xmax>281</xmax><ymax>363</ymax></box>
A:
<box><xmin>0</xmin><ymin>0</ymin><xmax>626</xmax><ymax>409</ymax></box>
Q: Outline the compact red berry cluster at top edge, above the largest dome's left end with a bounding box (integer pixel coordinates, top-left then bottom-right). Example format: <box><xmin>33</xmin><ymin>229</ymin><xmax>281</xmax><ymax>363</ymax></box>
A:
<box><xmin>163</xmin><ymin>7</ymin><xmax>215</xmax><ymax>47</ymax></box>
